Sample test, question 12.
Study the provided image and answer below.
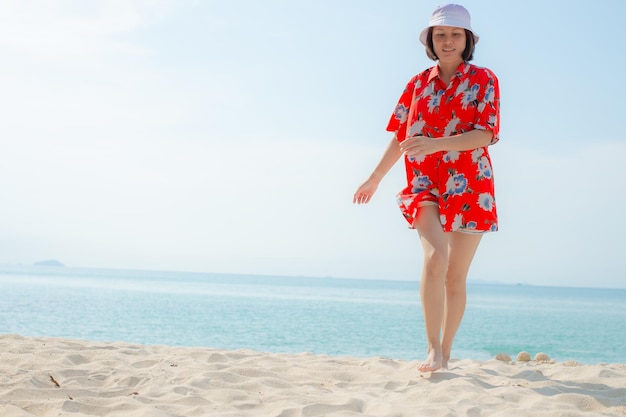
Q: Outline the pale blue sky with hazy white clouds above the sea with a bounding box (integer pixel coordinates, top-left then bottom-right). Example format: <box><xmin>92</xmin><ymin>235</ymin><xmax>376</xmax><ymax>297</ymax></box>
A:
<box><xmin>0</xmin><ymin>0</ymin><xmax>626</xmax><ymax>288</ymax></box>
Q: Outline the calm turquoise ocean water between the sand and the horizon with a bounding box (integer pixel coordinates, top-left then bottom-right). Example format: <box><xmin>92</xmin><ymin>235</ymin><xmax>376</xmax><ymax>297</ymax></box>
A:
<box><xmin>0</xmin><ymin>266</ymin><xmax>626</xmax><ymax>364</ymax></box>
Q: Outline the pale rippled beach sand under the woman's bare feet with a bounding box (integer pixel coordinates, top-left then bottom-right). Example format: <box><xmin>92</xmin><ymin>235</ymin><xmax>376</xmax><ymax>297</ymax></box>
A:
<box><xmin>0</xmin><ymin>335</ymin><xmax>626</xmax><ymax>417</ymax></box>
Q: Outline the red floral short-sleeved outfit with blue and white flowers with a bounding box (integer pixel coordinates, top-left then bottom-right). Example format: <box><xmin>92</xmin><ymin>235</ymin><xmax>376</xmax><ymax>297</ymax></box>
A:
<box><xmin>387</xmin><ymin>62</ymin><xmax>500</xmax><ymax>233</ymax></box>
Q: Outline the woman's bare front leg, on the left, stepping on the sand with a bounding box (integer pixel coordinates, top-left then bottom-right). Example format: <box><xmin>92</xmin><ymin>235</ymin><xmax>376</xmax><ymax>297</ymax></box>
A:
<box><xmin>414</xmin><ymin>206</ymin><xmax>449</xmax><ymax>372</ymax></box>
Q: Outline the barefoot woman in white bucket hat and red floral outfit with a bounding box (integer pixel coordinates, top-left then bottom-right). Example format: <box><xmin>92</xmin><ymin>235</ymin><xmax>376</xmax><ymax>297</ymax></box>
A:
<box><xmin>354</xmin><ymin>4</ymin><xmax>500</xmax><ymax>372</ymax></box>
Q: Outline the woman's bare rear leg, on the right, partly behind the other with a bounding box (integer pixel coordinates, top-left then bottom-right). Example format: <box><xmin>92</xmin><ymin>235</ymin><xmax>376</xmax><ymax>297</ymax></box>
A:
<box><xmin>441</xmin><ymin>232</ymin><xmax>482</xmax><ymax>368</ymax></box>
